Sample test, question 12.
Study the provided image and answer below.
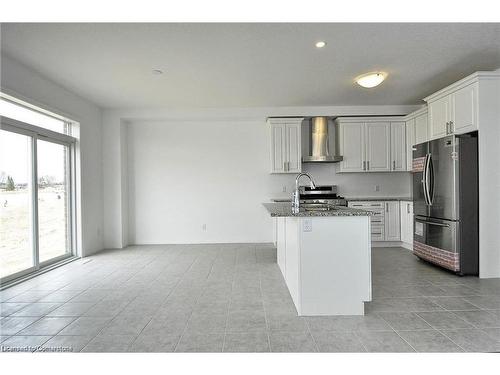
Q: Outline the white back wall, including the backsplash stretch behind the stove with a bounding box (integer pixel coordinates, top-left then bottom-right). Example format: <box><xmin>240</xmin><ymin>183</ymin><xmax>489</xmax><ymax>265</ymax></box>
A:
<box><xmin>127</xmin><ymin>120</ymin><xmax>410</xmax><ymax>244</ymax></box>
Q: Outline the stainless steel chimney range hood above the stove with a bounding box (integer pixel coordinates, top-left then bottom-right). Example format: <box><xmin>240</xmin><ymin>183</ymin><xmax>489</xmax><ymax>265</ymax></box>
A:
<box><xmin>302</xmin><ymin>116</ymin><xmax>344</xmax><ymax>163</ymax></box>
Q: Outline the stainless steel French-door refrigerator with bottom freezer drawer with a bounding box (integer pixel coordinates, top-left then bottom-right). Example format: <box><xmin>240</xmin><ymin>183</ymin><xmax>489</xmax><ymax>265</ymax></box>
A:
<box><xmin>412</xmin><ymin>132</ymin><xmax>479</xmax><ymax>275</ymax></box>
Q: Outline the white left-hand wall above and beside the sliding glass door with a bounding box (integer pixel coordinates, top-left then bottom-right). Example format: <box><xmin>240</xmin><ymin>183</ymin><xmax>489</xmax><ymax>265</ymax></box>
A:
<box><xmin>0</xmin><ymin>54</ymin><xmax>103</xmax><ymax>255</ymax></box>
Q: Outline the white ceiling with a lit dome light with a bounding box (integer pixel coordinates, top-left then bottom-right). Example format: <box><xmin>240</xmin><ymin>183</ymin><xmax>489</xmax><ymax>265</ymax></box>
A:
<box><xmin>1</xmin><ymin>23</ymin><xmax>500</xmax><ymax>108</ymax></box>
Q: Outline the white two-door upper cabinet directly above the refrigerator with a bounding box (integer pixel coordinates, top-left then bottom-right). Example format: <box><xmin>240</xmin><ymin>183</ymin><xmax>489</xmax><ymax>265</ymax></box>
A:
<box><xmin>424</xmin><ymin>73</ymin><xmax>479</xmax><ymax>139</ymax></box>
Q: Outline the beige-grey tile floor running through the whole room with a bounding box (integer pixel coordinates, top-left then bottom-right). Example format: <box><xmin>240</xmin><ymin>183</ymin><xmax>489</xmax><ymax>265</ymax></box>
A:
<box><xmin>0</xmin><ymin>244</ymin><xmax>500</xmax><ymax>352</ymax></box>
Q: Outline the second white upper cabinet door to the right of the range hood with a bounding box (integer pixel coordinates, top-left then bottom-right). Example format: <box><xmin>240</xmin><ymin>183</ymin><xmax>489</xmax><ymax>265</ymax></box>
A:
<box><xmin>366</xmin><ymin>122</ymin><xmax>391</xmax><ymax>172</ymax></box>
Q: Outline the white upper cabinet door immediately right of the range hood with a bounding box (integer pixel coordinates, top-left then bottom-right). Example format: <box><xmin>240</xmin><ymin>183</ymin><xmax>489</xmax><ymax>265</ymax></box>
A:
<box><xmin>339</xmin><ymin>122</ymin><xmax>365</xmax><ymax>172</ymax></box>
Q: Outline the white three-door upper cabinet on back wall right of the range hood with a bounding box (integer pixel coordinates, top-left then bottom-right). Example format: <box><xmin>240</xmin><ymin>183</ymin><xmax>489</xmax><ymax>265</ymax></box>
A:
<box><xmin>335</xmin><ymin>117</ymin><xmax>406</xmax><ymax>172</ymax></box>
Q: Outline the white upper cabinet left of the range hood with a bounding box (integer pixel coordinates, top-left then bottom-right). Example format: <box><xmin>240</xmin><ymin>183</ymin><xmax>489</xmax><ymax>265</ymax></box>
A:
<box><xmin>268</xmin><ymin>118</ymin><xmax>303</xmax><ymax>173</ymax></box>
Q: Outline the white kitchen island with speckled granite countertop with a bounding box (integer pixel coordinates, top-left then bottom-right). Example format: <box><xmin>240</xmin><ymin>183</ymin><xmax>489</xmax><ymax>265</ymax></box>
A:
<box><xmin>263</xmin><ymin>202</ymin><xmax>373</xmax><ymax>316</ymax></box>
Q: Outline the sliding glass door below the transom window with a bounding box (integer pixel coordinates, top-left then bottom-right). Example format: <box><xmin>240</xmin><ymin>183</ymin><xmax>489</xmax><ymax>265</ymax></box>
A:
<box><xmin>0</xmin><ymin>117</ymin><xmax>74</xmax><ymax>282</ymax></box>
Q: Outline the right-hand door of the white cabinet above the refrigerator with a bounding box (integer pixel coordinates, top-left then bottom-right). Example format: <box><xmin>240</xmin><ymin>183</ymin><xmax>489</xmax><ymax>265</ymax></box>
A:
<box><xmin>451</xmin><ymin>83</ymin><xmax>477</xmax><ymax>134</ymax></box>
